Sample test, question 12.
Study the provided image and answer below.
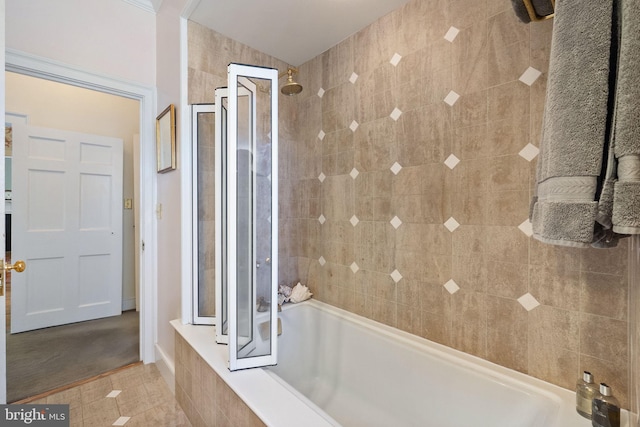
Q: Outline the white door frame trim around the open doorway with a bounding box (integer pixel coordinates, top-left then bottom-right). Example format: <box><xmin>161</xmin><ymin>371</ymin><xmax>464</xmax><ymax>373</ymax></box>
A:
<box><xmin>5</xmin><ymin>49</ymin><xmax>157</xmax><ymax>363</ymax></box>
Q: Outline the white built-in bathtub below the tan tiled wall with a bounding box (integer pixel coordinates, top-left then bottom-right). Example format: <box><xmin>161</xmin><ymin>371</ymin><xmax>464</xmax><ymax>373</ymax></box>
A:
<box><xmin>172</xmin><ymin>300</ymin><xmax>629</xmax><ymax>427</ymax></box>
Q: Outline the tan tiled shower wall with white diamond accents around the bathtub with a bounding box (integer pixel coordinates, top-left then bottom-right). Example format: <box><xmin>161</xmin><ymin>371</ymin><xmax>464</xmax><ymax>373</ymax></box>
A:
<box><xmin>189</xmin><ymin>0</ymin><xmax>628</xmax><ymax>412</ymax></box>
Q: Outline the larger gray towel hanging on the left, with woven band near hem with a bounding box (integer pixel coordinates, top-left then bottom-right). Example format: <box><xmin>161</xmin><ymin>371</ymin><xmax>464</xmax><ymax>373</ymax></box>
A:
<box><xmin>531</xmin><ymin>0</ymin><xmax>613</xmax><ymax>247</ymax></box>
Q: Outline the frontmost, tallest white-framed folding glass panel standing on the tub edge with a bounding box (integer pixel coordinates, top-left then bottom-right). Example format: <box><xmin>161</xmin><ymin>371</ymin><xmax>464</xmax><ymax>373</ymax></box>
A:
<box><xmin>225</xmin><ymin>64</ymin><xmax>278</xmax><ymax>370</ymax></box>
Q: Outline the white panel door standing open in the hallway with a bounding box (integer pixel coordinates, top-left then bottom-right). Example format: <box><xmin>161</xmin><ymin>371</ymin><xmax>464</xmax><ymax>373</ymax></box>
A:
<box><xmin>11</xmin><ymin>126</ymin><xmax>123</xmax><ymax>333</ymax></box>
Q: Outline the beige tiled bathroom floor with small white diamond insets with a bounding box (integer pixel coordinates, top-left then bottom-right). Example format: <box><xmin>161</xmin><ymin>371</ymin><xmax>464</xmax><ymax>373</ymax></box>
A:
<box><xmin>31</xmin><ymin>364</ymin><xmax>191</xmax><ymax>427</ymax></box>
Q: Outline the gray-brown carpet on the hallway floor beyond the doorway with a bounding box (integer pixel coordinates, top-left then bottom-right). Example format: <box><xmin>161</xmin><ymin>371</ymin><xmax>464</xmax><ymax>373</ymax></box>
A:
<box><xmin>7</xmin><ymin>310</ymin><xmax>140</xmax><ymax>402</ymax></box>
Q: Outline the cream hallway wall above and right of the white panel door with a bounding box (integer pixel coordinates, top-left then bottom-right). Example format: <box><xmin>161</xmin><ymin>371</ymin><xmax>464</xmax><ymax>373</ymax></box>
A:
<box><xmin>5</xmin><ymin>73</ymin><xmax>140</xmax><ymax>309</ymax></box>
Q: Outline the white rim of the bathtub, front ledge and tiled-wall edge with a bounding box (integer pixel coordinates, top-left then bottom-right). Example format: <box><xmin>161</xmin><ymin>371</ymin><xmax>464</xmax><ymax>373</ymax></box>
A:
<box><xmin>171</xmin><ymin>299</ymin><xmax>629</xmax><ymax>427</ymax></box>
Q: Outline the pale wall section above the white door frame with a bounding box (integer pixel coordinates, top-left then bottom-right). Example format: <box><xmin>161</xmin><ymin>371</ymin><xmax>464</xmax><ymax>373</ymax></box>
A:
<box><xmin>5</xmin><ymin>0</ymin><xmax>156</xmax><ymax>86</ymax></box>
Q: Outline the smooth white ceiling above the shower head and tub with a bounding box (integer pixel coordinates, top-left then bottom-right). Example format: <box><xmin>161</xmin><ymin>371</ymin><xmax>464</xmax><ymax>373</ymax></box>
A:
<box><xmin>188</xmin><ymin>0</ymin><xmax>409</xmax><ymax>66</ymax></box>
